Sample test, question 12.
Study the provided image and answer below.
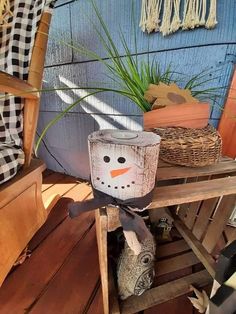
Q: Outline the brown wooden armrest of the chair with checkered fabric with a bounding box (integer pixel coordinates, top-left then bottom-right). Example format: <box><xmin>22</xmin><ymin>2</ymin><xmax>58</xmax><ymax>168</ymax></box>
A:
<box><xmin>0</xmin><ymin>71</ymin><xmax>39</xmax><ymax>100</ymax></box>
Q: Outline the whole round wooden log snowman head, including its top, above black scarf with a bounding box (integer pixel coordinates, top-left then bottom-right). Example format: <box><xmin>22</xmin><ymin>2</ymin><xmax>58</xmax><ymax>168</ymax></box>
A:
<box><xmin>89</xmin><ymin>130</ymin><xmax>160</xmax><ymax>200</ymax></box>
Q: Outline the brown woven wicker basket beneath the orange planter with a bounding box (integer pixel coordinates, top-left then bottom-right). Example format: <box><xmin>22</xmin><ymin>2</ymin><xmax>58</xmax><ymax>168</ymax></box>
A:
<box><xmin>152</xmin><ymin>125</ymin><xmax>222</xmax><ymax>167</ymax></box>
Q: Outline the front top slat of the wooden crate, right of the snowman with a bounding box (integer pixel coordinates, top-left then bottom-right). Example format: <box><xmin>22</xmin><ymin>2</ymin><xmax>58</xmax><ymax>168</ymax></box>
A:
<box><xmin>149</xmin><ymin>177</ymin><xmax>236</xmax><ymax>209</ymax></box>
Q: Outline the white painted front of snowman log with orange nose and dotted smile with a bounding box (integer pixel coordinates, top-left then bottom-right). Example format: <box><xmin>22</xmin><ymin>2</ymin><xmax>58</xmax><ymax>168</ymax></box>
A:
<box><xmin>90</xmin><ymin>144</ymin><xmax>147</xmax><ymax>200</ymax></box>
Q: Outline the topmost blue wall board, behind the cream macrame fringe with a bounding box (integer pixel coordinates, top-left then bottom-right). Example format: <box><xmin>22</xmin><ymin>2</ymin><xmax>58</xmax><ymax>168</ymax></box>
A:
<box><xmin>70</xmin><ymin>0</ymin><xmax>236</xmax><ymax>61</ymax></box>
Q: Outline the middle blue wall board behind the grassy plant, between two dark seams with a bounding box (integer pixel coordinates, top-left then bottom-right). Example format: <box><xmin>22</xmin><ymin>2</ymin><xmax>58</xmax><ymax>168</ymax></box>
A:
<box><xmin>41</xmin><ymin>45</ymin><xmax>236</xmax><ymax>119</ymax></box>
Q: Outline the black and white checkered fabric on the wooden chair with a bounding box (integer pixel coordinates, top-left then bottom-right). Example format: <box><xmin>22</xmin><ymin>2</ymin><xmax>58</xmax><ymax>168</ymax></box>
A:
<box><xmin>0</xmin><ymin>0</ymin><xmax>55</xmax><ymax>184</ymax></box>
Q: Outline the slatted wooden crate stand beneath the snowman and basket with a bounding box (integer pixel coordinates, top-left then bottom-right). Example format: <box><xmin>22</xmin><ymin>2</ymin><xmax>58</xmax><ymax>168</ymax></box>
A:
<box><xmin>96</xmin><ymin>158</ymin><xmax>236</xmax><ymax>314</ymax></box>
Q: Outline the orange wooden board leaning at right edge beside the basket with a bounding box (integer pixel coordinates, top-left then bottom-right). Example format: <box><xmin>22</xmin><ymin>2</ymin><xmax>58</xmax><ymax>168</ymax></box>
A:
<box><xmin>218</xmin><ymin>69</ymin><xmax>236</xmax><ymax>158</ymax></box>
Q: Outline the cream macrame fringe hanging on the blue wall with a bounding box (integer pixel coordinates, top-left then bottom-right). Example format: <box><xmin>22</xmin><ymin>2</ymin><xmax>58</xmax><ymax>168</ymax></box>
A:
<box><xmin>139</xmin><ymin>0</ymin><xmax>217</xmax><ymax>36</ymax></box>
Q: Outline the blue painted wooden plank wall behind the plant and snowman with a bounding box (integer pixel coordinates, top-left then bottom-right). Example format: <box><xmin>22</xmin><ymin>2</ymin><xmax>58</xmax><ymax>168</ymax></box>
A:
<box><xmin>38</xmin><ymin>0</ymin><xmax>236</xmax><ymax>178</ymax></box>
